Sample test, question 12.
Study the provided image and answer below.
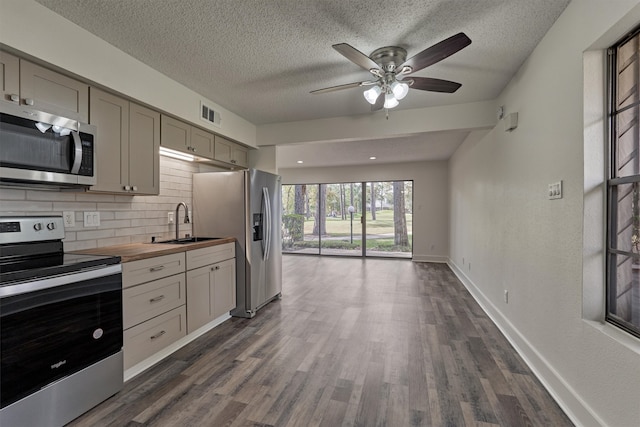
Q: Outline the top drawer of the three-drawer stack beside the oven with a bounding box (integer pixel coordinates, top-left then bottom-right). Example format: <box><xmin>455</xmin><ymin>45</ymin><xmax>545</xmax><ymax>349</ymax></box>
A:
<box><xmin>122</xmin><ymin>252</ymin><xmax>185</xmax><ymax>288</ymax></box>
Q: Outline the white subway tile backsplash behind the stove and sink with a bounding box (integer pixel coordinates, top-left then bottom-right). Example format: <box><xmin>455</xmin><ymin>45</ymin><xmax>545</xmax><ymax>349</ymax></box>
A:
<box><xmin>0</xmin><ymin>156</ymin><xmax>220</xmax><ymax>251</ymax></box>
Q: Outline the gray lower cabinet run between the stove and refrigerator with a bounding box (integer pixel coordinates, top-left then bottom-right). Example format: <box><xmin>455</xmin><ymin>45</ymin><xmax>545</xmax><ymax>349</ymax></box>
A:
<box><xmin>122</xmin><ymin>243</ymin><xmax>236</xmax><ymax>369</ymax></box>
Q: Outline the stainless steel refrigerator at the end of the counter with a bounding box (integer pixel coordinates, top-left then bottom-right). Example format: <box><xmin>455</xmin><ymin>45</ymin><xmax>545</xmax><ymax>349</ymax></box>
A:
<box><xmin>192</xmin><ymin>169</ymin><xmax>282</xmax><ymax>317</ymax></box>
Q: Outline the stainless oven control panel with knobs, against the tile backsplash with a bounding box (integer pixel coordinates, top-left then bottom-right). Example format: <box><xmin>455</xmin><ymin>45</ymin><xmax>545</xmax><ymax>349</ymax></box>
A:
<box><xmin>0</xmin><ymin>216</ymin><xmax>64</xmax><ymax>245</ymax></box>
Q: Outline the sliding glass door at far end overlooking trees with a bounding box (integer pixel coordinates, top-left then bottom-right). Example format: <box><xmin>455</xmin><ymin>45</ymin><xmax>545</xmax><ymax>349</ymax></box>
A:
<box><xmin>282</xmin><ymin>181</ymin><xmax>413</xmax><ymax>258</ymax></box>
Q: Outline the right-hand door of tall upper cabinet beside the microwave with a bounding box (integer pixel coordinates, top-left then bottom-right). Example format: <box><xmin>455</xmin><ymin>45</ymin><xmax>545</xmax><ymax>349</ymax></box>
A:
<box><xmin>129</xmin><ymin>103</ymin><xmax>160</xmax><ymax>195</ymax></box>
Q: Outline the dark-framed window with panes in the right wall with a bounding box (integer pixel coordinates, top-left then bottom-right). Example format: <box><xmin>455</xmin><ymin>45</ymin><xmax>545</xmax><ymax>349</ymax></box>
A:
<box><xmin>606</xmin><ymin>31</ymin><xmax>640</xmax><ymax>337</ymax></box>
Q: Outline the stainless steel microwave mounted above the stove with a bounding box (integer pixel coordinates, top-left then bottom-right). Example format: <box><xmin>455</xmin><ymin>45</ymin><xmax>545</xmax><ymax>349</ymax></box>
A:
<box><xmin>0</xmin><ymin>101</ymin><xmax>96</xmax><ymax>187</ymax></box>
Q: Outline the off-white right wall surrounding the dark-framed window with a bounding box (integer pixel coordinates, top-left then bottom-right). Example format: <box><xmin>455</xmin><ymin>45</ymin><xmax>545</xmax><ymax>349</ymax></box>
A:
<box><xmin>450</xmin><ymin>0</ymin><xmax>640</xmax><ymax>427</ymax></box>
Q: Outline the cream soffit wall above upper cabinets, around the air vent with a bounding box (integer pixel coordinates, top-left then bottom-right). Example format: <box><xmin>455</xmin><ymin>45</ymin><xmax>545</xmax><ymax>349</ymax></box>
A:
<box><xmin>0</xmin><ymin>0</ymin><xmax>256</xmax><ymax>147</ymax></box>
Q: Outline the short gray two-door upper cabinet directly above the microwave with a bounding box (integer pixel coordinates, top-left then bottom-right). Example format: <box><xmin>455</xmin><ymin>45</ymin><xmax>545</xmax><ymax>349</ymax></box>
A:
<box><xmin>0</xmin><ymin>52</ymin><xmax>89</xmax><ymax>123</ymax></box>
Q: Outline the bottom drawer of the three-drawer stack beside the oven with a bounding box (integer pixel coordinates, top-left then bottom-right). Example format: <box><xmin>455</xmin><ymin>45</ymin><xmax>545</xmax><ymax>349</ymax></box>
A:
<box><xmin>124</xmin><ymin>306</ymin><xmax>187</xmax><ymax>369</ymax></box>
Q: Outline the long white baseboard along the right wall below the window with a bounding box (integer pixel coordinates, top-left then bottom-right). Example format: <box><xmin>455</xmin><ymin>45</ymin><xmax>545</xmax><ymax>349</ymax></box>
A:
<box><xmin>447</xmin><ymin>259</ymin><xmax>605</xmax><ymax>426</ymax></box>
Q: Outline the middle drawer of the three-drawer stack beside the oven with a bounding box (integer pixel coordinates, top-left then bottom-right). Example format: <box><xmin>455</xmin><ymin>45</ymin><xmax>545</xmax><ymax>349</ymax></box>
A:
<box><xmin>122</xmin><ymin>273</ymin><xmax>186</xmax><ymax>329</ymax></box>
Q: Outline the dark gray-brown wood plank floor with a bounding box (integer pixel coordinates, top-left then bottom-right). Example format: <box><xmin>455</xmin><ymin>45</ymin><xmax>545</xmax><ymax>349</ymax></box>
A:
<box><xmin>71</xmin><ymin>256</ymin><xmax>572</xmax><ymax>427</ymax></box>
